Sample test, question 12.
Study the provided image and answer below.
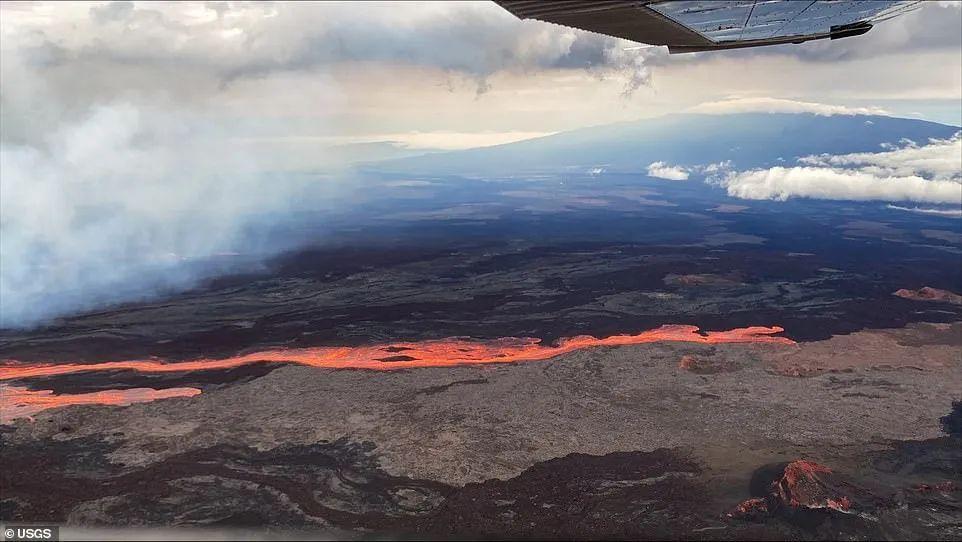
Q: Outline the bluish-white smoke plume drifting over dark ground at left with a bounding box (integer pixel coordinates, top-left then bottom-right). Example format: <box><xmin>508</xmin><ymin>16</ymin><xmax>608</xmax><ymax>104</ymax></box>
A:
<box><xmin>0</xmin><ymin>104</ymin><xmax>322</xmax><ymax>327</ymax></box>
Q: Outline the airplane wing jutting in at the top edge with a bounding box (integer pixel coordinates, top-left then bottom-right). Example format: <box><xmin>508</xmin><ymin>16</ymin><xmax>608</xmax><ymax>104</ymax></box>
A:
<box><xmin>495</xmin><ymin>0</ymin><xmax>921</xmax><ymax>53</ymax></box>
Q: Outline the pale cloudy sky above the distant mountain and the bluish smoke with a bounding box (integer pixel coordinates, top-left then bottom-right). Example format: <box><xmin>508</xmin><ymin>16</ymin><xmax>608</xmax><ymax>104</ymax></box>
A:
<box><xmin>2</xmin><ymin>2</ymin><xmax>962</xmax><ymax>162</ymax></box>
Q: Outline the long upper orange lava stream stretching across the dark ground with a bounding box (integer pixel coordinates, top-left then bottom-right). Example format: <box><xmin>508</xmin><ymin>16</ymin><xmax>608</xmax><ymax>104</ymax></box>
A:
<box><xmin>0</xmin><ymin>325</ymin><xmax>795</xmax><ymax>380</ymax></box>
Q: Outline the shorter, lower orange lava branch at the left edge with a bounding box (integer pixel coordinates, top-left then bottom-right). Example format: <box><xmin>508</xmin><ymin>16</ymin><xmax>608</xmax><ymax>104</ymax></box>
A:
<box><xmin>0</xmin><ymin>386</ymin><xmax>200</xmax><ymax>423</ymax></box>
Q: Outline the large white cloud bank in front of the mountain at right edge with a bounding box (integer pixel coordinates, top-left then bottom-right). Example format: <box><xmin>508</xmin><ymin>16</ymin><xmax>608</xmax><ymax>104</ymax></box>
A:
<box><xmin>720</xmin><ymin>134</ymin><xmax>962</xmax><ymax>205</ymax></box>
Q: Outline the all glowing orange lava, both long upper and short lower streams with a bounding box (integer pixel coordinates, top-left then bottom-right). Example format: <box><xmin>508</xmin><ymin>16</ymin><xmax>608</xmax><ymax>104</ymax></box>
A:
<box><xmin>0</xmin><ymin>326</ymin><xmax>795</xmax><ymax>423</ymax></box>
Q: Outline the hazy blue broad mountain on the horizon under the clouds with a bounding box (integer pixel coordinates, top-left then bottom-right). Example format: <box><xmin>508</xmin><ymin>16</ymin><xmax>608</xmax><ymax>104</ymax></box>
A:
<box><xmin>374</xmin><ymin>113</ymin><xmax>959</xmax><ymax>175</ymax></box>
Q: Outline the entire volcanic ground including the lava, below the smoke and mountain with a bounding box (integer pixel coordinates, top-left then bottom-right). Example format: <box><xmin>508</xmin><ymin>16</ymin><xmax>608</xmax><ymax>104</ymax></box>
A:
<box><xmin>0</xmin><ymin>173</ymin><xmax>962</xmax><ymax>540</ymax></box>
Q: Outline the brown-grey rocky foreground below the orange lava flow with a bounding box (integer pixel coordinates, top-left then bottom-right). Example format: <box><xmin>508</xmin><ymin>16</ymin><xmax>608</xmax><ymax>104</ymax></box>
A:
<box><xmin>2</xmin><ymin>325</ymin><xmax>962</xmax><ymax>539</ymax></box>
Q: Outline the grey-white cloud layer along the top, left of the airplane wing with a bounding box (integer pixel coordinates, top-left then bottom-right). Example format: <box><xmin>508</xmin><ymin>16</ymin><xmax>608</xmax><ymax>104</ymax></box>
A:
<box><xmin>5</xmin><ymin>2</ymin><xmax>663</xmax><ymax>103</ymax></box>
